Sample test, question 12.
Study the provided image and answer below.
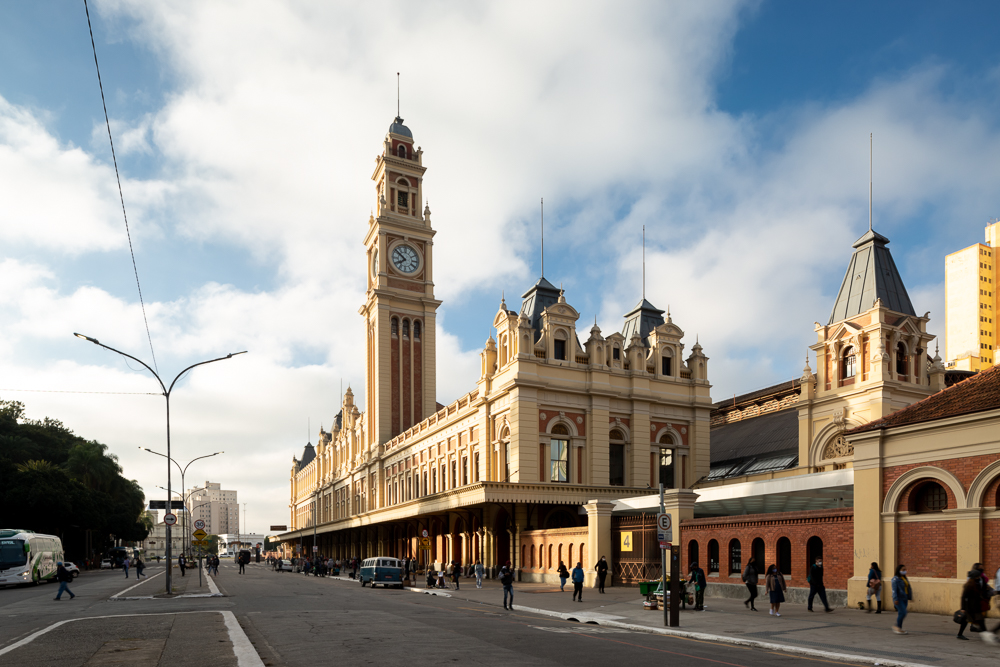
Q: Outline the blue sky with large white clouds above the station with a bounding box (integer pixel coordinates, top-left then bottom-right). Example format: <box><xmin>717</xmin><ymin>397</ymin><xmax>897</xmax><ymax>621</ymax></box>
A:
<box><xmin>0</xmin><ymin>0</ymin><xmax>1000</xmax><ymax>532</ymax></box>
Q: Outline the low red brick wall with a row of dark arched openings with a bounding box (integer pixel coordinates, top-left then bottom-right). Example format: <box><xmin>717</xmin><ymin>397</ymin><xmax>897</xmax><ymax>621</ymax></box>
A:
<box><xmin>681</xmin><ymin>508</ymin><xmax>852</xmax><ymax>589</ymax></box>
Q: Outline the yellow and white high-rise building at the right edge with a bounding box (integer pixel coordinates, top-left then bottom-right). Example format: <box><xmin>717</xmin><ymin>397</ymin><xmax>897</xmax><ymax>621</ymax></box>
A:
<box><xmin>944</xmin><ymin>221</ymin><xmax>1000</xmax><ymax>371</ymax></box>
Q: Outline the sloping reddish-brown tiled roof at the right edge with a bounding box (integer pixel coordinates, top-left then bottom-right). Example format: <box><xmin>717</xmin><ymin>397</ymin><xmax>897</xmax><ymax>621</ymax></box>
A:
<box><xmin>847</xmin><ymin>366</ymin><xmax>1000</xmax><ymax>434</ymax></box>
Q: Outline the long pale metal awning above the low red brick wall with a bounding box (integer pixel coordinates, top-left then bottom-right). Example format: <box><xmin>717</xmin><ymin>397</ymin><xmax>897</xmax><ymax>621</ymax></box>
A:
<box><xmin>614</xmin><ymin>468</ymin><xmax>854</xmax><ymax>518</ymax></box>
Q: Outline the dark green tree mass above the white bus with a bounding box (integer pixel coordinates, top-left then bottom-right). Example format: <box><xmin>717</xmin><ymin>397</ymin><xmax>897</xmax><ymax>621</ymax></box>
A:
<box><xmin>0</xmin><ymin>400</ymin><xmax>151</xmax><ymax>559</ymax></box>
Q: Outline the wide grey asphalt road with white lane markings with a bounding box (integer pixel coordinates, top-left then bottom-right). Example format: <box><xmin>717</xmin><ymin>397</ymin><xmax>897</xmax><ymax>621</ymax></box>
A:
<box><xmin>0</xmin><ymin>565</ymin><xmax>876</xmax><ymax>667</ymax></box>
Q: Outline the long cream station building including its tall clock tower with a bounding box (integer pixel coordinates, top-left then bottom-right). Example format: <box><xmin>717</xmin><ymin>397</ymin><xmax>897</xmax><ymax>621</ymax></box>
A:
<box><xmin>281</xmin><ymin>119</ymin><xmax>711</xmax><ymax>579</ymax></box>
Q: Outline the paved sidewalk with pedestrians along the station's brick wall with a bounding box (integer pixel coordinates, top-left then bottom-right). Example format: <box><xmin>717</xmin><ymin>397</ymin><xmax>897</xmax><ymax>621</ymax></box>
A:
<box><xmin>314</xmin><ymin>575</ymin><xmax>1000</xmax><ymax>667</ymax></box>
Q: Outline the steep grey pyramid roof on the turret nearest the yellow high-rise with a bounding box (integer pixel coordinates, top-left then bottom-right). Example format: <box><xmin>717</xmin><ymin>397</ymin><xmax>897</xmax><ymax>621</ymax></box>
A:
<box><xmin>829</xmin><ymin>230</ymin><xmax>916</xmax><ymax>324</ymax></box>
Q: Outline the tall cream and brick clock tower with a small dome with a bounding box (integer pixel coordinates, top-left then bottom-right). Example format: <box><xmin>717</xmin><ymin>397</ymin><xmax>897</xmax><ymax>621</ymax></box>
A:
<box><xmin>359</xmin><ymin>116</ymin><xmax>441</xmax><ymax>445</ymax></box>
